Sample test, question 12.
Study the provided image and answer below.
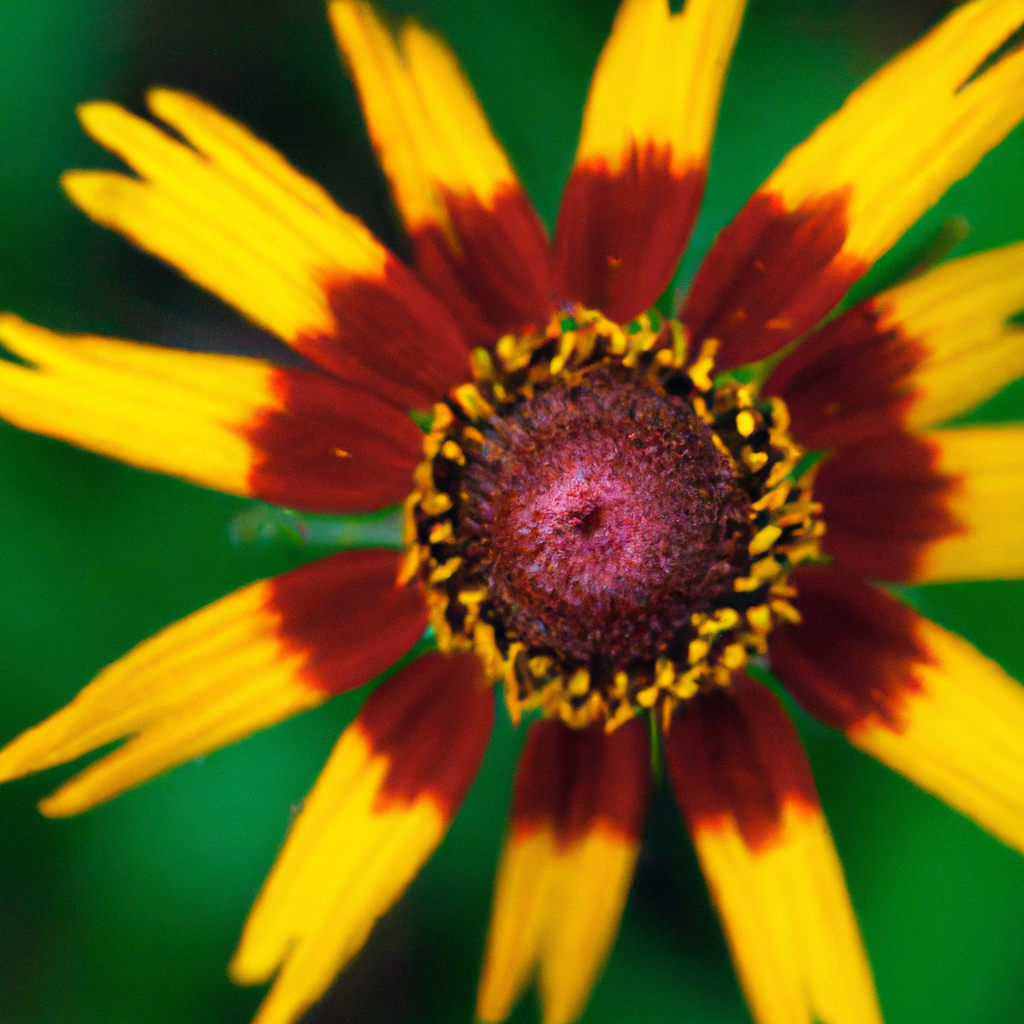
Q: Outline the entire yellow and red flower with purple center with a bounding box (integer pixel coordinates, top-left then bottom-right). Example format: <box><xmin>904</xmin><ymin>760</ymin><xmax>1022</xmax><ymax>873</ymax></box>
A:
<box><xmin>0</xmin><ymin>0</ymin><xmax>1024</xmax><ymax>1022</ymax></box>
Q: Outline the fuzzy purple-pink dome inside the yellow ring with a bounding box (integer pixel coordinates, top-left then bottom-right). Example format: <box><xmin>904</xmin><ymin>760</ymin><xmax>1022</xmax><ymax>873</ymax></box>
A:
<box><xmin>464</xmin><ymin>368</ymin><xmax>750</xmax><ymax>669</ymax></box>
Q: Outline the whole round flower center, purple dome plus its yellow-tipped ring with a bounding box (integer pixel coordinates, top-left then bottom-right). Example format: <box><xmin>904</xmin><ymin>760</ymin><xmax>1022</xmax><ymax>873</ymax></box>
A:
<box><xmin>407</xmin><ymin>308</ymin><xmax>823</xmax><ymax>728</ymax></box>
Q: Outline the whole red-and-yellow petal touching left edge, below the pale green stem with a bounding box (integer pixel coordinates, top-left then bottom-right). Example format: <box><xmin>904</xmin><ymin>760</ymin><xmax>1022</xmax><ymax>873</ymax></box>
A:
<box><xmin>0</xmin><ymin>550</ymin><xmax>427</xmax><ymax>817</ymax></box>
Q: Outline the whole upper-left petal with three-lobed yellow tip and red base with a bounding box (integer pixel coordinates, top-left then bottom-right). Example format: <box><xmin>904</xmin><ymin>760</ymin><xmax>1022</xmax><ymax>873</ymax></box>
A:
<box><xmin>63</xmin><ymin>89</ymin><xmax>468</xmax><ymax>409</ymax></box>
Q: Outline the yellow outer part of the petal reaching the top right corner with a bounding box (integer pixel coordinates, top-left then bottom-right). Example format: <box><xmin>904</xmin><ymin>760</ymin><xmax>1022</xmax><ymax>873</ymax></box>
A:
<box><xmin>762</xmin><ymin>0</ymin><xmax>1024</xmax><ymax>264</ymax></box>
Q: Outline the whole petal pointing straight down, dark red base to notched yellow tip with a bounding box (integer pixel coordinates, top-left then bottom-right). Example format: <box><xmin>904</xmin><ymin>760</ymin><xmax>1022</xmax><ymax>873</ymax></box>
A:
<box><xmin>477</xmin><ymin>719</ymin><xmax>650</xmax><ymax>1024</ymax></box>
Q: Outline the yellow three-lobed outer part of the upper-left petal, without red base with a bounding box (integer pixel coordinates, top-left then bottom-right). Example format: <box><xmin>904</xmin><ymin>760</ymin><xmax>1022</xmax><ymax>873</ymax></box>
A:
<box><xmin>63</xmin><ymin>89</ymin><xmax>387</xmax><ymax>342</ymax></box>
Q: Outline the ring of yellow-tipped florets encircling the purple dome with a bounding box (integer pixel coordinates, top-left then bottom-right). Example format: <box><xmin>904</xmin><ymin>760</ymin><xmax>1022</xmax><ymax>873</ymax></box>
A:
<box><xmin>402</xmin><ymin>308</ymin><xmax>823</xmax><ymax>731</ymax></box>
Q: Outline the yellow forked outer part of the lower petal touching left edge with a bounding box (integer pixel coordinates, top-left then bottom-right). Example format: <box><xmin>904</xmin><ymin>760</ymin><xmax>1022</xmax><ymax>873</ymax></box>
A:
<box><xmin>0</xmin><ymin>583</ymin><xmax>315</xmax><ymax>817</ymax></box>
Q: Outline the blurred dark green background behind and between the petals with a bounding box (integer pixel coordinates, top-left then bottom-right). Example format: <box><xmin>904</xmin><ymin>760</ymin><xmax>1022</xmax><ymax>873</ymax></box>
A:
<box><xmin>0</xmin><ymin>0</ymin><xmax>1024</xmax><ymax>1024</ymax></box>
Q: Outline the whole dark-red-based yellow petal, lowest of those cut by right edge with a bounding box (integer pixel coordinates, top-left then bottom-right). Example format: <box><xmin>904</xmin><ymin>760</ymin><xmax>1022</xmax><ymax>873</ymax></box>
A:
<box><xmin>769</xmin><ymin>565</ymin><xmax>1024</xmax><ymax>852</ymax></box>
